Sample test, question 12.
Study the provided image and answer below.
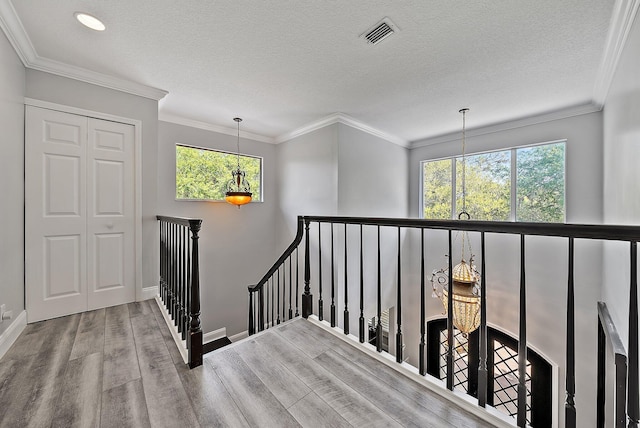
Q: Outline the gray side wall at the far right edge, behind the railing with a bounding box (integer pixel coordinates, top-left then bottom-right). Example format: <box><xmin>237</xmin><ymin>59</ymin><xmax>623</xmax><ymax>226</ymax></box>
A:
<box><xmin>602</xmin><ymin>3</ymin><xmax>640</xmax><ymax>396</ymax></box>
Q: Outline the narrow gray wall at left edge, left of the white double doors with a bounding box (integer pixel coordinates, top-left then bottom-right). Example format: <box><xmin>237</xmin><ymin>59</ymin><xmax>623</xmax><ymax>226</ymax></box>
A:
<box><xmin>0</xmin><ymin>31</ymin><xmax>25</xmax><ymax>335</ymax></box>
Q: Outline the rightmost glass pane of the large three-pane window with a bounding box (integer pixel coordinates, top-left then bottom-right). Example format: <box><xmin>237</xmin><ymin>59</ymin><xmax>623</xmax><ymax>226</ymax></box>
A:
<box><xmin>516</xmin><ymin>143</ymin><xmax>565</xmax><ymax>223</ymax></box>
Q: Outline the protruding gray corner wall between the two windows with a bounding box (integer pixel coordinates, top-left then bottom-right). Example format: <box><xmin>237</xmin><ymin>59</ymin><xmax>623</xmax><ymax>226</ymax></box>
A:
<box><xmin>278</xmin><ymin>123</ymin><xmax>408</xmax><ymax>324</ymax></box>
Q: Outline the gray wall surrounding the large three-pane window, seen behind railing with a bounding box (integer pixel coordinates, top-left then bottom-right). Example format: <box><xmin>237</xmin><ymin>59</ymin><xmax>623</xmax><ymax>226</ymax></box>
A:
<box><xmin>407</xmin><ymin>112</ymin><xmax>603</xmax><ymax>426</ymax></box>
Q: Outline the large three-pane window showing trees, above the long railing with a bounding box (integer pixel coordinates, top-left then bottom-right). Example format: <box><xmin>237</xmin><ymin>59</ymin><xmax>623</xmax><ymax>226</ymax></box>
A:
<box><xmin>422</xmin><ymin>142</ymin><xmax>565</xmax><ymax>223</ymax></box>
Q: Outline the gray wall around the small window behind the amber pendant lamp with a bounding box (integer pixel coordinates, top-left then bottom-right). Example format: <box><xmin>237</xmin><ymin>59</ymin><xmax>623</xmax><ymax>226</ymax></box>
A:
<box><xmin>157</xmin><ymin>118</ymin><xmax>278</xmax><ymax>336</ymax></box>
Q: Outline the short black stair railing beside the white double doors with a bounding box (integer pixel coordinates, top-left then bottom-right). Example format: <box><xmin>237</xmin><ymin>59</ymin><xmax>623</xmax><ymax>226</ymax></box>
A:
<box><xmin>156</xmin><ymin>216</ymin><xmax>202</xmax><ymax>368</ymax></box>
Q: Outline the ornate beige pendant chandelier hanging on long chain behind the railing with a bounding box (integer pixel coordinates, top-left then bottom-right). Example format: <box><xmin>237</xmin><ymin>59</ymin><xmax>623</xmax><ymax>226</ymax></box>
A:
<box><xmin>431</xmin><ymin>108</ymin><xmax>480</xmax><ymax>337</ymax></box>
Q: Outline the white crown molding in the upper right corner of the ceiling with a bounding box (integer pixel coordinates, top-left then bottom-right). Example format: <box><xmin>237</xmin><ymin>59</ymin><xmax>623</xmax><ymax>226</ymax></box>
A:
<box><xmin>593</xmin><ymin>0</ymin><xmax>640</xmax><ymax>107</ymax></box>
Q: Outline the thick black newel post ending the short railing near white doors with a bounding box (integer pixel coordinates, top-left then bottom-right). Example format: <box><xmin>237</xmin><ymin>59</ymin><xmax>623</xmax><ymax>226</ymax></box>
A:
<box><xmin>187</xmin><ymin>220</ymin><xmax>202</xmax><ymax>368</ymax></box>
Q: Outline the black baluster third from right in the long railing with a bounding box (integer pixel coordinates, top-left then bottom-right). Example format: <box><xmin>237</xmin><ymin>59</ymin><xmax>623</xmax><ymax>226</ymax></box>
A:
<box><xmin>517</xmin><ymin>234</ymin><xmax>527</xmax><ymax>427</ymax></box>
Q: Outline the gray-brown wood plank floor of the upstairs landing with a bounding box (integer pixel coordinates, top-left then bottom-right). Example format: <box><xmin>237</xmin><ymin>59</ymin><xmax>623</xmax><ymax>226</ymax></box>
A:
<box><xmin>0</xmin><ymin>300</ymin><xmax>490</xmax><ymax>428</ymax></box>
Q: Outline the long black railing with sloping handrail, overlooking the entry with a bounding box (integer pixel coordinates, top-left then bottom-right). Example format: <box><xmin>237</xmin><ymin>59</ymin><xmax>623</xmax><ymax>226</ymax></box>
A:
<box><xmin>249</xmin><ymin>216</ymin><xmax>640</xmax><ymax>428</ymax></box>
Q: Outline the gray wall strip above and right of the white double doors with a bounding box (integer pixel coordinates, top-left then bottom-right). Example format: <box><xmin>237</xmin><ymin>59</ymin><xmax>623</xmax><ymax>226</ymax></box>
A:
<box><xmin>26</xmin><ymin>69</ymin><xmax>158</xmax><ymax>294</ymax></box>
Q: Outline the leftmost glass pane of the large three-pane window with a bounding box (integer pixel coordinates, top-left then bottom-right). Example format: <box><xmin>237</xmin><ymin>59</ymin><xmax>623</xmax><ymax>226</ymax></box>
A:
<box><xmin>422</xmin><ymin>159</ymin><xmax>452</xmax><ymax>220</ymax></box>
